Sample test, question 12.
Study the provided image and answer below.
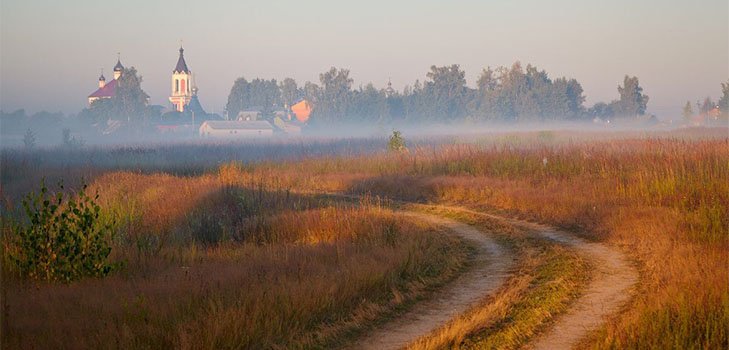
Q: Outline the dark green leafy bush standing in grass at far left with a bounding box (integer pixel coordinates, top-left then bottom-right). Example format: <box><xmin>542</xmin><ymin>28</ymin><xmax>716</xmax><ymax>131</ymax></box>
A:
<box><xmin>7</xmin><ymin>181</ymin><xmax>116</xmax><ymax>282</ymax></box>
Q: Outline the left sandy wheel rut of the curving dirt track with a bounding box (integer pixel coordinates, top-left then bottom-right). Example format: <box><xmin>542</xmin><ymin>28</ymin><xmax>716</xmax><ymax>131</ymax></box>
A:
<box><xmin>353</xmin><ymin>213</ymin><xmax>514</xmax><ymax>350</ymax></box>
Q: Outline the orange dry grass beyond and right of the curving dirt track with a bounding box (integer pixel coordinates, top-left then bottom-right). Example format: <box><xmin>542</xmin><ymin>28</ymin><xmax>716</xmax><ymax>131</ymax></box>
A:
<box><xmin>222</xmin><ymin>133</ymin><xmax>729</xmax><ymax>348</ymax></box>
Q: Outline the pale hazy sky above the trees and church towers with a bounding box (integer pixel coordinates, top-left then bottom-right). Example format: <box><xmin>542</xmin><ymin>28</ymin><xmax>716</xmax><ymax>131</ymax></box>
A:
<box><xmin>0</xmin><ymin>0</ymin><xmax>729</xmax><ymax>114</ymax></box>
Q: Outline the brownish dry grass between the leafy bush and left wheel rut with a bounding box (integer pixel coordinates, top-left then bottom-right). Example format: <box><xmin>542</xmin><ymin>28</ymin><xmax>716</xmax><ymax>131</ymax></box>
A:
<box><xmin>2</xmin><ymin>173</ymin><xmax>468</xmax><ymax>348</ymax></box>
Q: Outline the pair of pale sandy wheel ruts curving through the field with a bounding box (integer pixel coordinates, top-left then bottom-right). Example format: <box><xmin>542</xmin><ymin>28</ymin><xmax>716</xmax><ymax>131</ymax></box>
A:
<box><xmin>354</xmin><ymin>206</ymin><xmax>638</xmax><ymax>349</ymax></box>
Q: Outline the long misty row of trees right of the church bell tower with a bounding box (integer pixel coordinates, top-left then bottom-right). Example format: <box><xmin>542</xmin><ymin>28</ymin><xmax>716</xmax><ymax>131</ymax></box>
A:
<box><xmin>226</xmin><ymin>62</ymin><xmax>660</xmax><ymax>124</ymax></box>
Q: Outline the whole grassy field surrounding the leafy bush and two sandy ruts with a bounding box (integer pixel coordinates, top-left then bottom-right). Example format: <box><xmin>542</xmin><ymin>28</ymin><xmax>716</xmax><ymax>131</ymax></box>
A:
<box><xmin>0</xmin><ymin>128</ymin><xmax>729</xmax><ymax>349</ymax></box>
